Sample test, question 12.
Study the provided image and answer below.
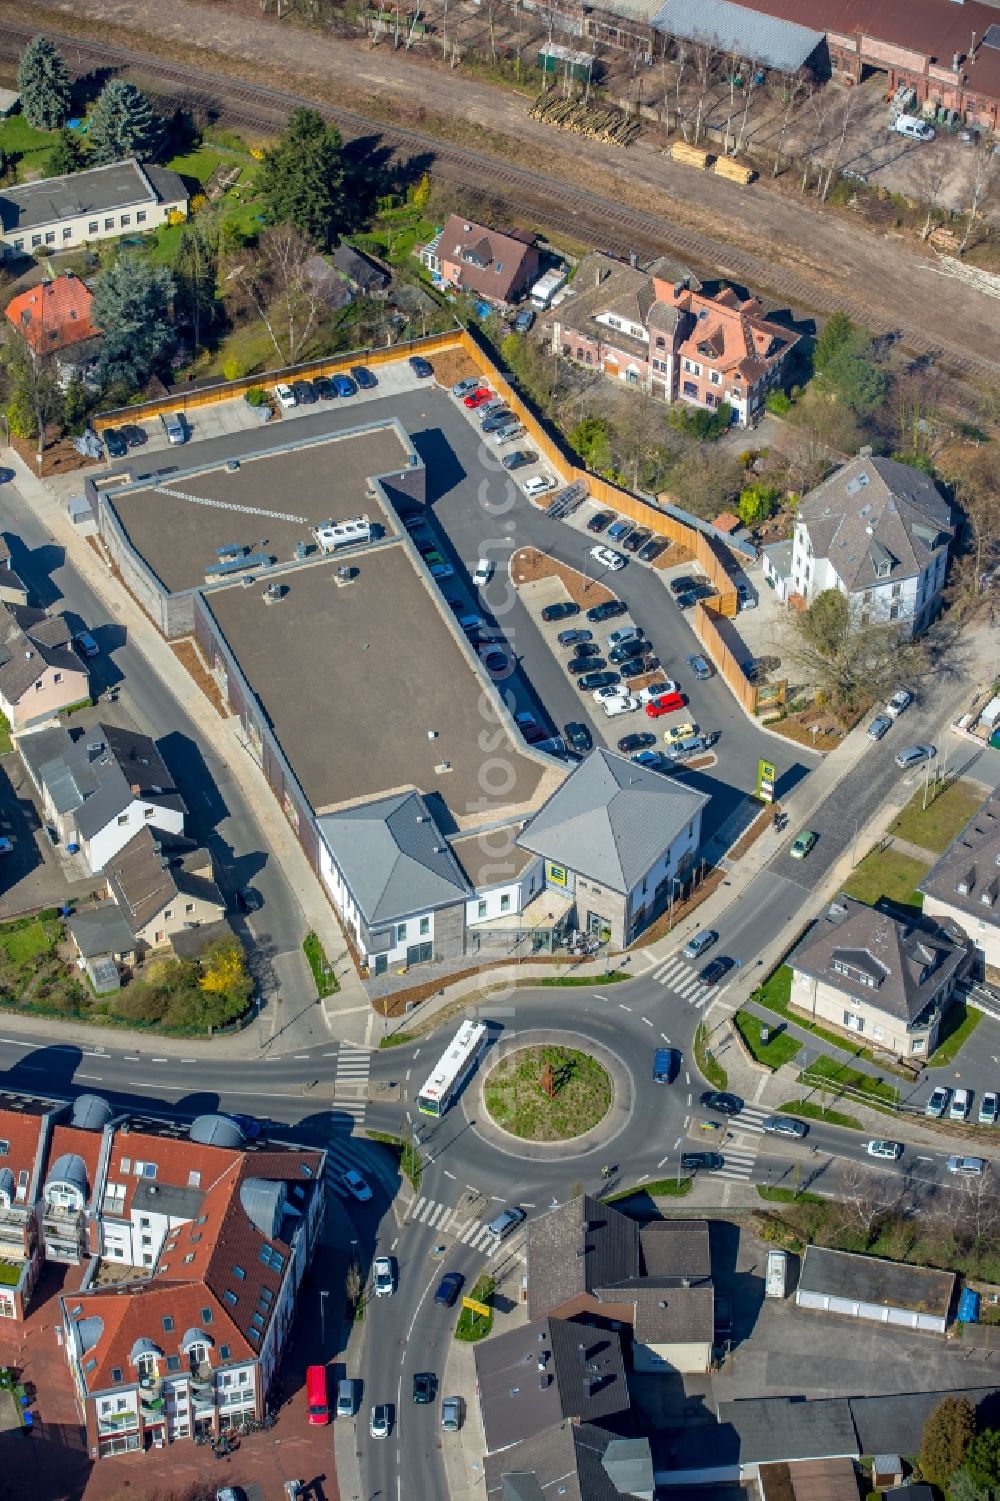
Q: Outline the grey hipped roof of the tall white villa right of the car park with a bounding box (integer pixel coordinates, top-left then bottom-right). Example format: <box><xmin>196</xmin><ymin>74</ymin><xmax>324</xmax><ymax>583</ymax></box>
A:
<box><xmin>799</xmin><ymin>455</ymin><xmax>955</xmax><ymax>591</ymax></box>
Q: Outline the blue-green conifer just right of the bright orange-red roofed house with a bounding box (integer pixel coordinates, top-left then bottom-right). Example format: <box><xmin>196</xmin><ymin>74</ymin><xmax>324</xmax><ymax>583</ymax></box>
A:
<box><xmin>92</xmin><ymin>251</ymin><xmax>174</xmax><ymax>392</ymax></box>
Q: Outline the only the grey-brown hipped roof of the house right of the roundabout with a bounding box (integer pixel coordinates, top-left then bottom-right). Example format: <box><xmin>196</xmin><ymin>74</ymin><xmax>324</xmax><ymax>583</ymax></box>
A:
<box><xmin>788</xmin><ymin>893</ymin><xmax>968</xmax><ymax>1025</ymax></box>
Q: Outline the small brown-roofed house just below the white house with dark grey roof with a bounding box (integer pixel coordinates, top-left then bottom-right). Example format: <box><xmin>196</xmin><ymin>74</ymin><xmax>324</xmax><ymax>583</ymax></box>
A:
<box><xmin>104</xmin><ymin>827</ymin><xmax>225</xmax><ymax>953</ymax></box>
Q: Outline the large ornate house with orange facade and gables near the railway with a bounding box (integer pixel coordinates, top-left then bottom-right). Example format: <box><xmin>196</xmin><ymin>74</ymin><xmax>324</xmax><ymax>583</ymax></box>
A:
<box><xmin>553</xmin><ymin>251</ymin><xmax>799</xmax><ymax>426</ymax></box>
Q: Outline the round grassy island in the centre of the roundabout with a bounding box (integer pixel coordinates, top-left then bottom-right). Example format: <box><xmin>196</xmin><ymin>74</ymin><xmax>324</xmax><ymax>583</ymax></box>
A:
<box><xmin>483</xmin><ymin>1046</ymin><xmax>613</xmax><ymax>1141</ymax></box>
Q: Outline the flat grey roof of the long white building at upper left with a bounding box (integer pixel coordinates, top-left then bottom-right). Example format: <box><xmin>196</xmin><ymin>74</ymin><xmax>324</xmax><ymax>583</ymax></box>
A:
<box><xmin>0</xmin><ymin>161</ymin><xmax>188</xmax><ymax>234</ymax></box>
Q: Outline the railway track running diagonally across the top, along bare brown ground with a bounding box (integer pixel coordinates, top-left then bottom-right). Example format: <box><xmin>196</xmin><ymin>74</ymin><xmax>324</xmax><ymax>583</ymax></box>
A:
<box><xmin>0</xmin><ymin>21</ymin><xmax>1000</xmax><ymax>381</ymax></box>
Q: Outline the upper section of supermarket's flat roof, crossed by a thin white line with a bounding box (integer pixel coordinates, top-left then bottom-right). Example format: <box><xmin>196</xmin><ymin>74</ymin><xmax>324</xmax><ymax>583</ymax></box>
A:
<box><xmin>108</xmin><ymin>423</ymin><xmax>410</xmax><ymax>593</ymax></box>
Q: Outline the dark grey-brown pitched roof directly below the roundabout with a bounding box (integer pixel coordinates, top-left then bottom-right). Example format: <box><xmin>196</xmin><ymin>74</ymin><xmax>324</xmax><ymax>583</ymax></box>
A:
<box><xmin>527</xmin><ymin>1193</ymin><xmax>640</xmax><ymax>1318</ymax></box>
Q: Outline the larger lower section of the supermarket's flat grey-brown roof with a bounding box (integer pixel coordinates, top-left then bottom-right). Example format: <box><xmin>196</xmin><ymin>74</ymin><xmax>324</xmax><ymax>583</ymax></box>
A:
<box><xmin>198</xmin><ymin>540</ymin><xmax>546</xmax><ymax>833</ymax></box>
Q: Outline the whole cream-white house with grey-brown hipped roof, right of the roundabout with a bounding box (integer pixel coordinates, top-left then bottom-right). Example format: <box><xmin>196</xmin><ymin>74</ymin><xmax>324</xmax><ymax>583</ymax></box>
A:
<box><xmin>788</xmin><ymin>895</ymin><xmax>970</xmax><ymax>1058</ymax></box>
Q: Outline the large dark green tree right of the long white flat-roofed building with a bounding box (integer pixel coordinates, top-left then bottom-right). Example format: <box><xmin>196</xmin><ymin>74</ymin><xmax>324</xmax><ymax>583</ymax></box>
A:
<box><xmin>257</xmin><ymin>108</ymin><xmax>344</xmax><ymax>249</ymax></box>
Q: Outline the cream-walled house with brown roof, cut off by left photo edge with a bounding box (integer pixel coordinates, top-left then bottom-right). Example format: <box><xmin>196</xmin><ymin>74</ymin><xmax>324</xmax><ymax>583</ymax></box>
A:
<box><xmin>0</xmin><ymin>603</ymin><xmax>90</xmax><ymax>729</ymax></box>
